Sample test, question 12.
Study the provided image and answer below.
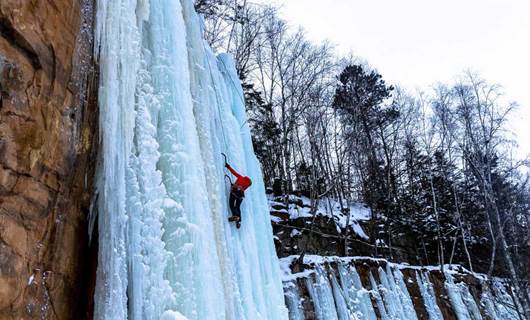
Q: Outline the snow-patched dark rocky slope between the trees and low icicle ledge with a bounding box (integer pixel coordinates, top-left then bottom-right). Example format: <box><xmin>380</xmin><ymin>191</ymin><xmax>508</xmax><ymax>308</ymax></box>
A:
<box><xmin>269</xmin><ymin>190</ymin><xmax>418</xmax><ymax>264</ymax></box>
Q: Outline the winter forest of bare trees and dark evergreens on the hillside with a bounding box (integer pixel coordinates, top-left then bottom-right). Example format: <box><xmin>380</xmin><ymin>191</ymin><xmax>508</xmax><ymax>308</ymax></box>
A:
<box><xmin>195</xmin><ymin>0</ymin><xmax>530</xmax><ymax>310</ymax></box>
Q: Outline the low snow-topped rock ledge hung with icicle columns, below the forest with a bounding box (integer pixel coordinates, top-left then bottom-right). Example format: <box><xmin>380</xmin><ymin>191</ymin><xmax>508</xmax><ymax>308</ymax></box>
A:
<box><xmin>281</xmin><ymin>255</ymin><xmax>521</xmax><ymax>320</ymax></box>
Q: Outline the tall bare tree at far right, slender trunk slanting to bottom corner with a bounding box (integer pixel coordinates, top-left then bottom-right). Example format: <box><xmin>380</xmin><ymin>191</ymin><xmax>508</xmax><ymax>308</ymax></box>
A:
<box><xmin>450</xmin><ymin>73</ymin><xmax>530</xmax><ymax>317</ymax></box>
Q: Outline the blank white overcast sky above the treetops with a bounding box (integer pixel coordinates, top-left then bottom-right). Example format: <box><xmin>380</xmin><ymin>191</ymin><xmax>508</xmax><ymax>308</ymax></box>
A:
<box><xmin>253</xmin><ymin>0</ymin><xmax>530</xmax><ymax>157</ymax></box>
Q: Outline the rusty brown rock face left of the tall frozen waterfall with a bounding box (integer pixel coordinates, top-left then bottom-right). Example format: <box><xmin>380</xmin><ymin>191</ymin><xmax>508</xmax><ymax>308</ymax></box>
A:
<box><xmin>0</xmin><ymin>0</ymin><xmax>97</xmax><ymax>319</ymax></box>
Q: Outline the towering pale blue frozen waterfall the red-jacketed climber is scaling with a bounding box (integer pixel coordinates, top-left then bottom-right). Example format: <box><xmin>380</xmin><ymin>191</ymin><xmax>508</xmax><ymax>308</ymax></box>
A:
<box><xmin>95</xmin><ymin>0</ymin><xmax>287</xmax><ymax>320</ymax></box>
